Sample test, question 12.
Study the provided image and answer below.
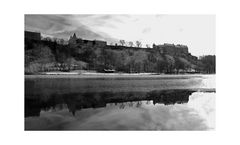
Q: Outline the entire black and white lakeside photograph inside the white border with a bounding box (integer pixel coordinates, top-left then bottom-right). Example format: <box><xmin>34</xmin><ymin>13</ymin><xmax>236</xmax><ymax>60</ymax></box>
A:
<box><xmin>24</xmin><ymin>14</ymin><xmax>216</xmax><ymax>131</ymax></box>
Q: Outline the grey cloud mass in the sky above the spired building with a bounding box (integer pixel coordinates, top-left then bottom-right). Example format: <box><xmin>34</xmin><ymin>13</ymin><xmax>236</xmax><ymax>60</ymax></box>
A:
<box><xmin>25</xmin><ymin>15</ymin><xmax>117</xmax><ymax>42</ymax></box>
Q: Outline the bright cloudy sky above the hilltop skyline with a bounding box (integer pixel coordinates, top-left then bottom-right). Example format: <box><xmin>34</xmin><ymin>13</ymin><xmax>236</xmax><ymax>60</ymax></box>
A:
<box><xmin>25</xmin><ymin>14</ymin><xmax>216</xmax><ymax>56</ymax></box>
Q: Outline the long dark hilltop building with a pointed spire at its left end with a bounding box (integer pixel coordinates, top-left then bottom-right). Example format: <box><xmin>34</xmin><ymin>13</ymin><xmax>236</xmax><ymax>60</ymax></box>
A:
<box><xmin>68</xmin><ymin>33</ymin><xmax>107</xmax><ymax>47</ymax></box>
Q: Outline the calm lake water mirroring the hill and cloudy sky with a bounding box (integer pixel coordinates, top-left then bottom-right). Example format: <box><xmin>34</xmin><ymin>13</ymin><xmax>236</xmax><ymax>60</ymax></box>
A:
<box><xmin>25</xmin><ymin>75</ymin><xmax>215</xmax><ymax>130</ymax></box>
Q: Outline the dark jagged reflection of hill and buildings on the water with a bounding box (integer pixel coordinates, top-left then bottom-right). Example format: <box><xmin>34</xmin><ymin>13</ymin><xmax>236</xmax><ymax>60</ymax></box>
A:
<box><xmin>25</xmin><ymin>90</ymin><xmax>194</xmax><ymax>117</ymax></box>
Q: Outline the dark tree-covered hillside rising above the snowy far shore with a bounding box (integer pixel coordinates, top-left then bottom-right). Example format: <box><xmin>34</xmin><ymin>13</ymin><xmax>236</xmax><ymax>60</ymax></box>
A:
<box><xmin>25</xmin><ymin>35</ymin><xmax>215</xmax><ymax>74</ymax></box>
